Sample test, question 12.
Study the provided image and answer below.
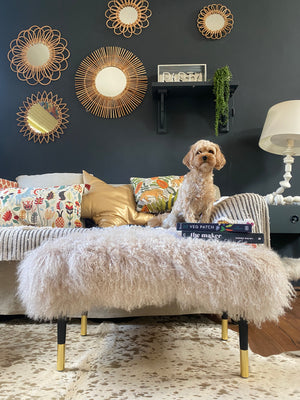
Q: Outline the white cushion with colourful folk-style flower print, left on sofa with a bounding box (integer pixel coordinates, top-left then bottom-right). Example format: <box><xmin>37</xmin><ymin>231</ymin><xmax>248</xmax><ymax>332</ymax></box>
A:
<box><xmin>0</xmin><ymin>185</ymin><xmax>84</xmax><ymax>228</ymax></box>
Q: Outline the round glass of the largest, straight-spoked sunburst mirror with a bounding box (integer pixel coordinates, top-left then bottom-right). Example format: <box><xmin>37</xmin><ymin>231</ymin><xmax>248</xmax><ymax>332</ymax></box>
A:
<box><xmin>95</xmin><ymin>67</ymin><xmax>127</xmax><ymax>97</ymax></box>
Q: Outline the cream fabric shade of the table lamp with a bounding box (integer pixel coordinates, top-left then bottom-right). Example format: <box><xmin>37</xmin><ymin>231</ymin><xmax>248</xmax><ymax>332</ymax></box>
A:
<box><xmin>258</xmin><ymin>100</ymin><xmax>300</xmax><ymax>156</ymax></box>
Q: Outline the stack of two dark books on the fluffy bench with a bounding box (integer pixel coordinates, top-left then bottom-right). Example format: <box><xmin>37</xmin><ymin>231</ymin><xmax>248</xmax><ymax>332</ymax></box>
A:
<box><xmin>176</xmin><ymin>222</ymin><xmax>264</xmax><ymax>244</ymax></box>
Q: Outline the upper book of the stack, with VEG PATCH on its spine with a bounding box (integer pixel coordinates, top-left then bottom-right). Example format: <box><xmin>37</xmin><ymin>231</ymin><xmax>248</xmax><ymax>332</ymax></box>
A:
<box><xmin>176</xmin><ymin>222</ymin><xmax>252</xmax><ymax>233</ymax></box>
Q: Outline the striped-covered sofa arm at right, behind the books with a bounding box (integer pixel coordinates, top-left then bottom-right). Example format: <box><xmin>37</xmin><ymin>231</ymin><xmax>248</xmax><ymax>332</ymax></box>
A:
<box><xmin>211</xmin><ymin>193</ymin><xmax>271</xmax><ymax>247</ymax></box>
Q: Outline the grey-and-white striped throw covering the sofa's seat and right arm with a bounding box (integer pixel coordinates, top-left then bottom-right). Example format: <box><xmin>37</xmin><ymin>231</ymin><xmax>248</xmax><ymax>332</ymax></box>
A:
<box><xmin>0</xmin><ymin>193</ymin><xmax>270</xmax><ymax>261</ymax></box>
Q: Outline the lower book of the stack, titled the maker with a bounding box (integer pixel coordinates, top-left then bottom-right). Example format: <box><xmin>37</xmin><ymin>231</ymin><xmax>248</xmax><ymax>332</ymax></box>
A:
<box><xmin>182</xmin><ymin>230</ymin><xmax>264</xmax><ymax>244</ymax></box>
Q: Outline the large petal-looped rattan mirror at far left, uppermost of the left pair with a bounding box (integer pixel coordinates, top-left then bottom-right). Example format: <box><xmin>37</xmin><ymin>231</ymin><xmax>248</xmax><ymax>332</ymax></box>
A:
<box><xmin>7</xmin><ymin>25</ymin><xmax>70</xmax><ymax>85</ymax></box>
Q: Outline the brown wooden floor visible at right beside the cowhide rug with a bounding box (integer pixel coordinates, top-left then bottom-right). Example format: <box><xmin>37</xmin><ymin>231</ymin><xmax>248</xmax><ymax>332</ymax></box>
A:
<box><xmin>211</xmin><ymin>288</ymin><xmax>300</xmax><ymax>357</ymax></box>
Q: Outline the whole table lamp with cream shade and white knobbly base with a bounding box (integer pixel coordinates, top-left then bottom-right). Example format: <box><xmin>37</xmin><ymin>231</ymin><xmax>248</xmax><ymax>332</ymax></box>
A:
<box><xmin>258</xmin><ymin>100</ymin><xmax>300</xmax><ymax>205</ymax></box>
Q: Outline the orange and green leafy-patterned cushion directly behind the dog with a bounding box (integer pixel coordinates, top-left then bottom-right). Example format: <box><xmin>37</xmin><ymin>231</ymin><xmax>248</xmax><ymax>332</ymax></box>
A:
<box><xmin>130</xmin><ymin>175</ymin><xmax>184</xmax><ymax>214</ymax></box>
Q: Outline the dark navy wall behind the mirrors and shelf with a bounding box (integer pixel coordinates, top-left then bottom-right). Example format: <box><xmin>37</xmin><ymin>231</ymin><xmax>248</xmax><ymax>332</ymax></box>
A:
<box><xmin>0</xmin><ymin>0</ymin><xmax>300</xmax><ymax>200</ymax></box>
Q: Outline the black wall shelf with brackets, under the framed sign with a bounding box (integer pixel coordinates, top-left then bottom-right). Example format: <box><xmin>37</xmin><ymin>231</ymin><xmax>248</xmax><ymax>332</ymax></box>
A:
<box><xmin>152</xmin><ymin>82</ymin><xmax>238</xmax><ymax>133</ymax></box>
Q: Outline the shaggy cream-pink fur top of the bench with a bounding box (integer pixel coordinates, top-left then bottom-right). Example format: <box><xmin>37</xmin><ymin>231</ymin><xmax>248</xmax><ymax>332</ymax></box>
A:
<box><xmin>18</xmin><ymin>226</ymin><xmax>294</xmax><ymax>325</ymax></box>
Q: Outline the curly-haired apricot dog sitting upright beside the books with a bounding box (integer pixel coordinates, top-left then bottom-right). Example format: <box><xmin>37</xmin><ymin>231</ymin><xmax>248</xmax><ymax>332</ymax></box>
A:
<box><xmin>148</xmin><ymin>140</ymin><xmax>226</xmax><ymax>228</ymax></box>
